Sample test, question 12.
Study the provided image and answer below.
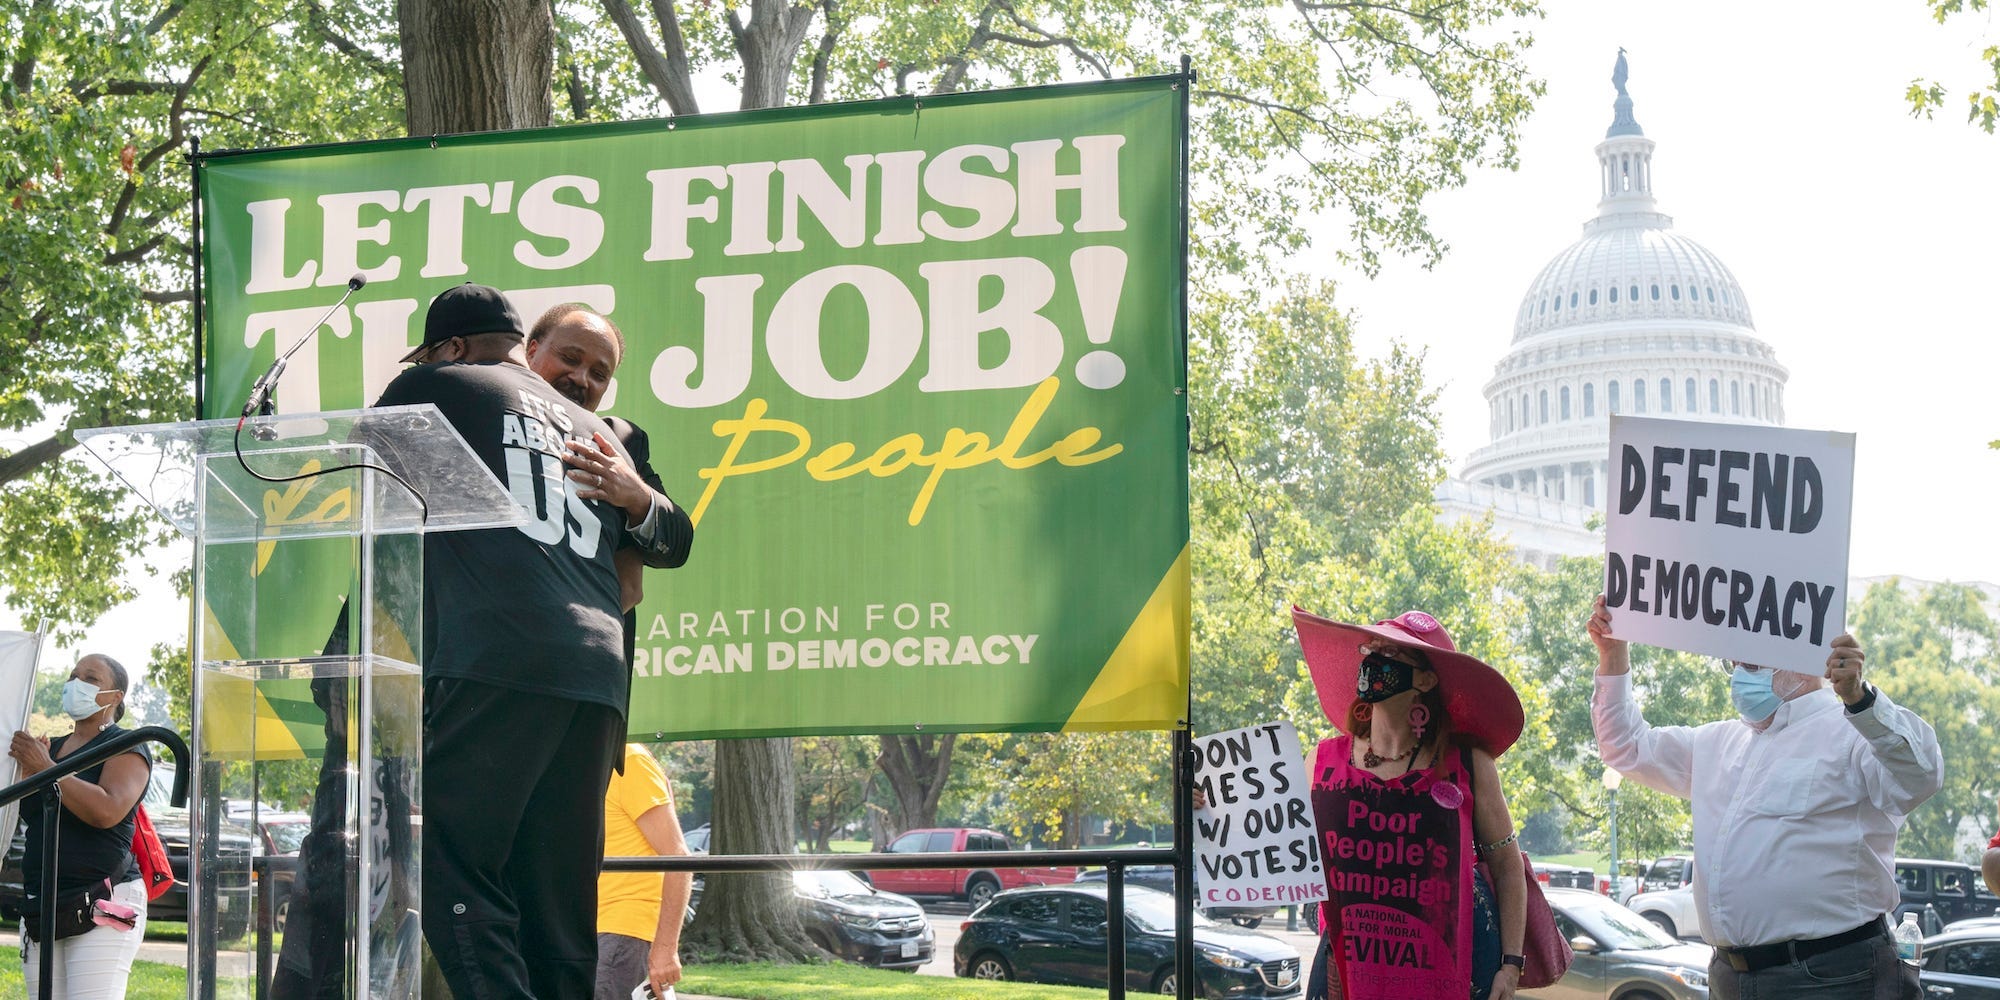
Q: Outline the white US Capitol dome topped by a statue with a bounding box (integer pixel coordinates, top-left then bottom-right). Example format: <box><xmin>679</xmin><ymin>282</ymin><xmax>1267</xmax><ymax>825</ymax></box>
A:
<box><xmin>1436</xmin><ymin>50</ymin><xmax>1788</xmax><ymax>566</ymax></box>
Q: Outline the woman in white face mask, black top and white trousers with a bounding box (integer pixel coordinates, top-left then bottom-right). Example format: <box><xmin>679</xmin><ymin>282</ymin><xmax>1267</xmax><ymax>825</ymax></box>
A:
<box><xmin>8</xmin><ymin>654</ymin><xmax>152</xmax><ymax>1000</ymax></box>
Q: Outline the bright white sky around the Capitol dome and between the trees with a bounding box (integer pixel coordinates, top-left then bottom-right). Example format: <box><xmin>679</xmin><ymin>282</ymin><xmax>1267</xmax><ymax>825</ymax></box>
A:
<box><xmin>0</xmin><ymin>0</ymin><xmax>2000</xmax><ymax>680</ymax></box>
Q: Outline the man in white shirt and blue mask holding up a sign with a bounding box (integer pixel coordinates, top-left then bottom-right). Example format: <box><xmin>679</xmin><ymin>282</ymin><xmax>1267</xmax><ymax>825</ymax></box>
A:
<box><xmin>1588</xmin><ymin>598</ymin><xmax>1944</xmax><ymax>1000</ymax></box>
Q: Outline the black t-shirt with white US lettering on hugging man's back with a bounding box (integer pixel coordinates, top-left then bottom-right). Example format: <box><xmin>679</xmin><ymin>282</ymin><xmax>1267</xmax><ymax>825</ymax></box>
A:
<box><xmin>376</xmin><ymin>362</ymin><xmax>628</xmax><ymax>714</ymax></box>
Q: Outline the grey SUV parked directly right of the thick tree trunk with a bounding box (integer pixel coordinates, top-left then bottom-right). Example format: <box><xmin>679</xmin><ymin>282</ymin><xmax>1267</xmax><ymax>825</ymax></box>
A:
<box><xmin>792</xmin><ymin>872</ymin><xmax>938</xmax><ymax>972</ymax></box>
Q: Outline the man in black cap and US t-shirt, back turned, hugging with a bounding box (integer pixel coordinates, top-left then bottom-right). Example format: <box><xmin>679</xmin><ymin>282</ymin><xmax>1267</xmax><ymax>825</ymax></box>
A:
<box><xmin>376</xmin><ymin>284</ymin><xmax>654</xmax><ymax>1000</ymax></box>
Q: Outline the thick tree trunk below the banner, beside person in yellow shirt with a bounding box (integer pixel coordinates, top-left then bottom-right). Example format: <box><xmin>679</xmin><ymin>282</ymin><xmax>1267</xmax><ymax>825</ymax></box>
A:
<box><xmin>680</xmin><ymin>740</ymin><xmax>820</xmax><ymax>962</ymax></box>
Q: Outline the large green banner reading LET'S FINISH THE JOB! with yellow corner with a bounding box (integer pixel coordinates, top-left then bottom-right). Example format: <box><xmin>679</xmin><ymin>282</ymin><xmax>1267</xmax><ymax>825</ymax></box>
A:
<box><xmin>200</xmin><ymin>76</ymin><xmax>1188</xmax><ymax>738</ymax></box>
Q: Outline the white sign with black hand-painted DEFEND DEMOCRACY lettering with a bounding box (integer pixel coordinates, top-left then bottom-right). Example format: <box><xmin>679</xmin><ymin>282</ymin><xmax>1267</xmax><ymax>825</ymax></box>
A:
<box><xmin>1604</xmin><ymin>416</ymin><xmax>1854</xmax><ymax>674</ymax></box>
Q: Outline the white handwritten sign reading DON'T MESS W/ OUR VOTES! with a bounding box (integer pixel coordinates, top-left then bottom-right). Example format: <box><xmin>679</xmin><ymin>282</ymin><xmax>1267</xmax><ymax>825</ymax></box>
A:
<box><xmin>1194</xmin><ymin>722</ymin><xmax>1326</xmax><ymax>906</ymax></box>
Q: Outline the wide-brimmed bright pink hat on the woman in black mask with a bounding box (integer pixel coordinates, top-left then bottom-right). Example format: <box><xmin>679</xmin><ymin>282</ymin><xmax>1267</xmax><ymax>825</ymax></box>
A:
<box><xmin>1292</xmin><ymin>606</ymin><xmax>1526</xmax><ymax>756</ymax></box>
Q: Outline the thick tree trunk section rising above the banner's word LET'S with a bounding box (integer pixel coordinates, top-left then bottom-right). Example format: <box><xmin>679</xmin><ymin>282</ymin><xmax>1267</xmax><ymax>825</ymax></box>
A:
<box><xmin>396</xmin><ymin>0</ymin><xmax>556</xmax><ymax>136</ymax></box>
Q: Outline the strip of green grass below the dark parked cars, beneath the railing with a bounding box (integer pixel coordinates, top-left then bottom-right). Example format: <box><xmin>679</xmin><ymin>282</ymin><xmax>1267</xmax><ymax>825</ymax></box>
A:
<box><xmin>680</xmin><ymin>964</ymin><xmax>1104</xmax><ymax>1000</ymax></box>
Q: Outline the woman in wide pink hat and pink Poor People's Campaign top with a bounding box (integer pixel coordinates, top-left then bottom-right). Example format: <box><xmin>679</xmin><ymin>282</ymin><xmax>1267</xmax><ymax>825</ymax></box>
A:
<box><xmin>1292</xmin><ymin>608</ymin><xmax>1526</xmax><ymax>1000</ymax></box>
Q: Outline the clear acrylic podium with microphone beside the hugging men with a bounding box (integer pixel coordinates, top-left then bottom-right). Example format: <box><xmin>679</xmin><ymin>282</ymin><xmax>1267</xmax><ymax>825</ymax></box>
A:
<box><xmin>78</xmin><ymin>404</ymin><xmax>522</xmax><ymax>1000</ymax></box>
